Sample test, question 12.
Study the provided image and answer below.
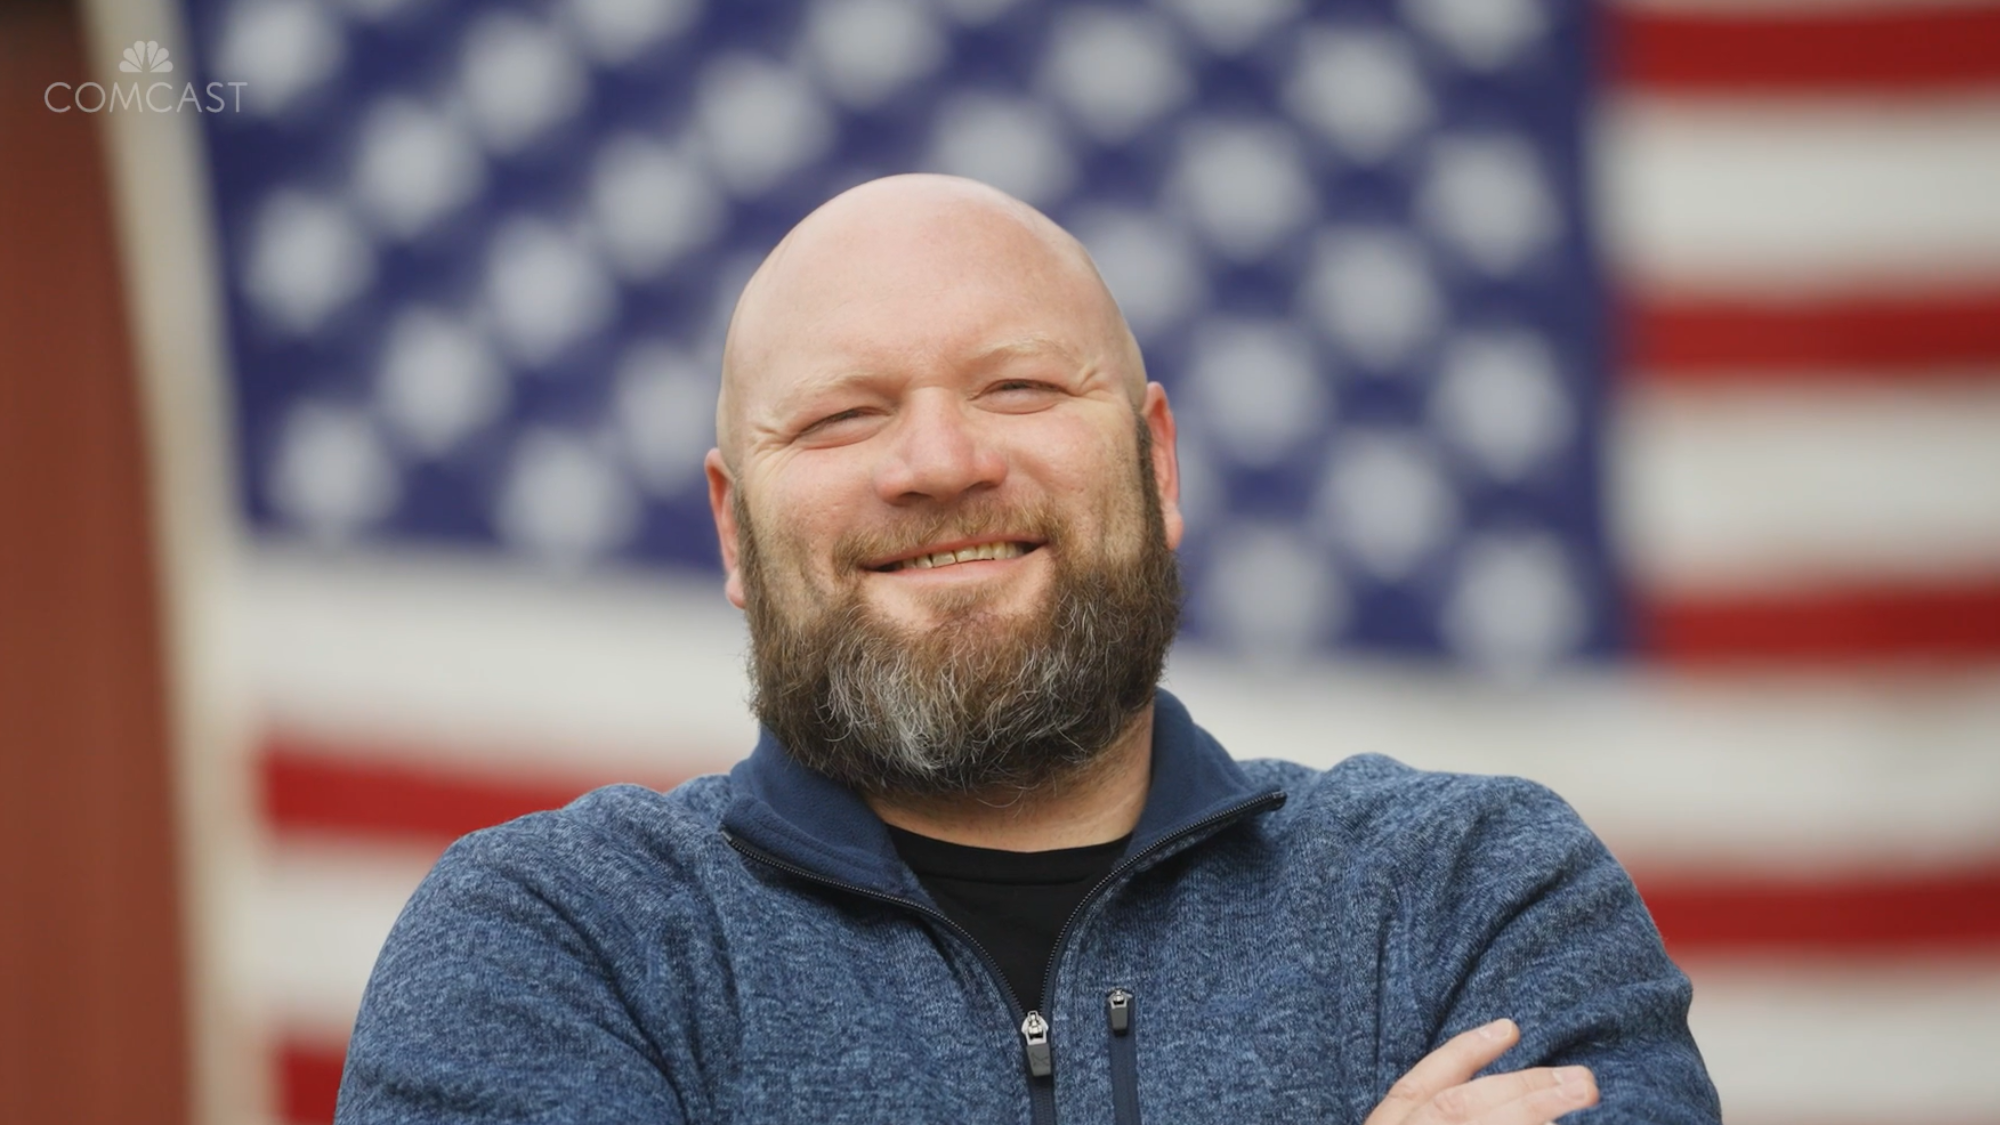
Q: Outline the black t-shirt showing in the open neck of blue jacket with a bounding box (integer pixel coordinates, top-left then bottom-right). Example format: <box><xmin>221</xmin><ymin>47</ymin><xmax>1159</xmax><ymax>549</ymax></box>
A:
<box><xmin>888</xmin><ymin>827</ymin><xmax>1132</xmax><ymax>1011</ymax></box>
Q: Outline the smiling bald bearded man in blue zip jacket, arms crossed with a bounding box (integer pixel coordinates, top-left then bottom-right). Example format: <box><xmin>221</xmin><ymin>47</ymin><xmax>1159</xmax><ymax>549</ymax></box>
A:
<box><xmin>340</xmin><ymin>176</ymin><xmax>1718</xmax><ymax>1125</ymax></box>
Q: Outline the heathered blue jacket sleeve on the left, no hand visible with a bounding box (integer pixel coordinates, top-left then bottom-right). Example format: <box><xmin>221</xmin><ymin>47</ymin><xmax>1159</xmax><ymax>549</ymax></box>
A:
<box><xmin>334</xmin><ymin>823</ymin><xmax>686</xmax><ymax>1125</ymax></box>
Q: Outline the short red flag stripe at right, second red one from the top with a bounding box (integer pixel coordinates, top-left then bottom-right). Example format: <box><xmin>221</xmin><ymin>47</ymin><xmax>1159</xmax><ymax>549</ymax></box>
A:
<box><xmin>1624</xmin><ymin>284</ymin><xmax>2000</xmax><ymax>382</ymax></box>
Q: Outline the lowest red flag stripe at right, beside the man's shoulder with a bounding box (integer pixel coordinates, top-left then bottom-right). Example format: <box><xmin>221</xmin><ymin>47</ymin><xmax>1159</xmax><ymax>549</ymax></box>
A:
<box><xmin>1638</xmin><ymin>863</ymin><xmax>2000</xmax><ymax>957</ymax></box>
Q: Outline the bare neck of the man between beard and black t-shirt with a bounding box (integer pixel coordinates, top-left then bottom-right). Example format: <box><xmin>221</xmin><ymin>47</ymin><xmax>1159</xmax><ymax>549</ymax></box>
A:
<box><xmin>866</xmin><ymin>705</ymin><xmax>1152</xmax><ymax>851</ymax></box>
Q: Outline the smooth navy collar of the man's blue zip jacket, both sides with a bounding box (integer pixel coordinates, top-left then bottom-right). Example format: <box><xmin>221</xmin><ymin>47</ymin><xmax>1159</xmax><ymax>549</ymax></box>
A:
<box><xmin>722</xmin><ymin>691</ymin><xmax>1280</xmax><ymax>897</ymax></box>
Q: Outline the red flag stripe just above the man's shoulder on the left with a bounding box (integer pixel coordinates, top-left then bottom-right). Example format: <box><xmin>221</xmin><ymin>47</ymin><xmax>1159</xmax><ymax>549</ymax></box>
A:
<box><xmin>262</xmin><ymin>737</ymin><xmax>704</xmax><ymax>845</ymax></box>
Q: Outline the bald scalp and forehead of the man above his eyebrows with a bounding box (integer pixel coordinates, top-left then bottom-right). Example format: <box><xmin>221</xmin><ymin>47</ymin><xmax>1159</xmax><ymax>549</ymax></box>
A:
<box><xmin>716</xmin><ymin>174</ymin><xmax>1146</xmax><ymax>466</ymax></box>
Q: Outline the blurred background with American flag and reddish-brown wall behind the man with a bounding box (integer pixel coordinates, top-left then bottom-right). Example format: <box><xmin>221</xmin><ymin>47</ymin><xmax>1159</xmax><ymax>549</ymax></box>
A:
<box><xmin>0</xmin><ymin>0</ymin><xmax>2000</xmax><ymax>1125</ymax></box>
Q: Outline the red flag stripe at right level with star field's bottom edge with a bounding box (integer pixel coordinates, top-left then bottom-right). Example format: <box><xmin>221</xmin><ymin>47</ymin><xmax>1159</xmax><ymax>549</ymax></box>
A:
<box><xmin>1636</xmin><ymin>572</ymin><xmax>2000</xmax><ymax>667</ymax></box>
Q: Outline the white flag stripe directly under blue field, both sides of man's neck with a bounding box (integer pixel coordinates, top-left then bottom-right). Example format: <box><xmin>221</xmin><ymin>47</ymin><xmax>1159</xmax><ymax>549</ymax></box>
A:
<box><xmin>244</xmin><ymin>554</ymin><xmax>2000</xmax><ymax>869</ymax></box>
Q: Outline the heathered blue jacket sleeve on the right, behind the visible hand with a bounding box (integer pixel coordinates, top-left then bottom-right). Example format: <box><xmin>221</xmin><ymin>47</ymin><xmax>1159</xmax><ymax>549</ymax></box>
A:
<box><xmin>1384</xmin><ymin>777</ymin><xmax>1722</xmax><ymax>1125</ymax></box>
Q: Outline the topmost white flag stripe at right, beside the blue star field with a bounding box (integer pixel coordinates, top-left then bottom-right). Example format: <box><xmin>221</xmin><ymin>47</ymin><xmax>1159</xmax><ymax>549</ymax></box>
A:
<box><xmin>1594</xmin><ymin>96</ymin><xmax>2000</xmax><ymax>294</ymax></box>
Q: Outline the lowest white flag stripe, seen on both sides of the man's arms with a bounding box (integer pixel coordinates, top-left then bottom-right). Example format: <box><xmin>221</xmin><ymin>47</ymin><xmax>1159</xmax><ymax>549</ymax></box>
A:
<box><xmin>250</xmin><ymin>841</ymin><xmax>2000</xmax><ymax>1125</ymax></box>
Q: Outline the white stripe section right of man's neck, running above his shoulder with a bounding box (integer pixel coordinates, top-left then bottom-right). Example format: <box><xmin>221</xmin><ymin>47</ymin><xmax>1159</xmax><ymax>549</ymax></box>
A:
<box><xmin>1168</xmin><ymin>653</ymin><xmax>2000</xmax><ymax>873</ymax></box>
